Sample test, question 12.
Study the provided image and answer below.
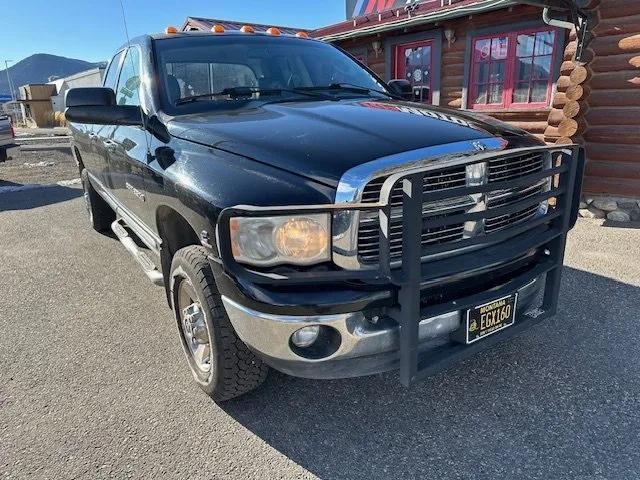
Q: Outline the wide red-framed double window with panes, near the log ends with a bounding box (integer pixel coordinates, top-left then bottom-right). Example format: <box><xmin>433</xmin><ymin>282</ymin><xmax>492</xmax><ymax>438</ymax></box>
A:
<box><xmin>469</xmin><ymin>30</ymin><xmax>557</xmax><ymax>110</ymax></box>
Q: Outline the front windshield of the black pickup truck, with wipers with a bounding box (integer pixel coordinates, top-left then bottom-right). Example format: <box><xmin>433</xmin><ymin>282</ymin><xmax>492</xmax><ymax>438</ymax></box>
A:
<box><xmin>155</xmin><ymin>35</ymin><xmax>389</xmax><ymax>114</ymax></box>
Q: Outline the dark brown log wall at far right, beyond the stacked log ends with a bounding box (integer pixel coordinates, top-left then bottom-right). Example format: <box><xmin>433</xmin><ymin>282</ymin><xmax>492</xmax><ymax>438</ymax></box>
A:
<box><xmin>581</xmin><ymin>0</ymin><xmax>640</xmax><ymax>198</ymax></box>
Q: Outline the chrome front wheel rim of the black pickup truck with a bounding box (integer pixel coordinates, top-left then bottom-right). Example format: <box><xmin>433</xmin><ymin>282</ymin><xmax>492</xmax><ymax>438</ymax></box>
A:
<box><xmin>178</xmin><ymin>279</ymin><xmax>211</xmax><ymax>373</ymax></box>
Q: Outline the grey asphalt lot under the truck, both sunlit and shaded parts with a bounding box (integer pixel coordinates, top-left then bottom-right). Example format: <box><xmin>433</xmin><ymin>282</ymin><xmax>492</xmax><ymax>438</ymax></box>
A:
<box><xmin>0</xmin><ymin>186</ymin><xmax>640</xmax><ymax>480</ymax></box>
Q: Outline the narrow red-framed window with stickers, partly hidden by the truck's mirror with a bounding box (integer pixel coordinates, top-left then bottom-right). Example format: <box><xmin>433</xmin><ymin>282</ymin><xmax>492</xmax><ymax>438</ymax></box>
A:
<box><xmin>395</xmin><ymin>41</ymin><xmax>433</xmax><ymax>103</ymax></box>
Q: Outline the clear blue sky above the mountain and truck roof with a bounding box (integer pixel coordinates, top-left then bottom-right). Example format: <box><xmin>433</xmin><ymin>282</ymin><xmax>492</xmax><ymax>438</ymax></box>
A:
<box><xmin>0</xmin><ymin>0</ymin><xmax>345</xmax><ymax>63</ymax></box>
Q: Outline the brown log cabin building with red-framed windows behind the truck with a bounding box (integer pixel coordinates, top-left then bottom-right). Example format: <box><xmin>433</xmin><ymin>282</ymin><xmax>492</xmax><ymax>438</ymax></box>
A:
<box><xmin>182</xmin><ymin>0</ymin><xmax>640</xmax><ymax>207</ymax></box>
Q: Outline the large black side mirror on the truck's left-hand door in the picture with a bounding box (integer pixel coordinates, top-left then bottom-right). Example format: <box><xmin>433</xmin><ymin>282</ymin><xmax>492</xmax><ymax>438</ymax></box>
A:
<box><xmin>64</xmin><ymin>87</ymin><xmax>143</xmax><ymax>126</ymax></box>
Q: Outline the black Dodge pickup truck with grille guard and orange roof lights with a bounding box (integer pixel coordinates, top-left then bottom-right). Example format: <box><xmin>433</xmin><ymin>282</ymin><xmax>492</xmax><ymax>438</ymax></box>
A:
<box><xmin>66</xmin><ymin>1</ymin><xmax>584</xmax><ymax>401</ymax></box>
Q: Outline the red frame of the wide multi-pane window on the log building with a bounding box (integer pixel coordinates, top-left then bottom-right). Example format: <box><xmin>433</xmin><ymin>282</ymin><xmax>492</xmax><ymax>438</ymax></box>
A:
<box><xmin>467</xmin><ymin>27</ymin><xmax>560</xmax><ymax>110</ymax></box>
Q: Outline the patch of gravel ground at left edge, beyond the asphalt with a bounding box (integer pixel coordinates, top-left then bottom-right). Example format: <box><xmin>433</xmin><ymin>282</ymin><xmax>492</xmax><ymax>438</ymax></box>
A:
<box><xmin>0</xmin><ymin>139</ymin><xmax>78</xmax><ymax>188</ymax></box>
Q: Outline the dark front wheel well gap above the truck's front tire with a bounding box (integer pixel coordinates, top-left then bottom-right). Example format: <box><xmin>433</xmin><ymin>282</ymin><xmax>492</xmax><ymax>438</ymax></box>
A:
<box><xmin>156</xmin><ymin>206</ymin><xmax>200</xmax><ymax>306</ymax></box>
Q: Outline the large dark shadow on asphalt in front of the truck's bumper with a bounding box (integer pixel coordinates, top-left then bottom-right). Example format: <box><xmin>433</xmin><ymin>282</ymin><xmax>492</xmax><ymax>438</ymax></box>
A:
<box><xmin>222</xmin><ymin>268</ymin><xmax>640</xmax><ymax>479</ymax></box>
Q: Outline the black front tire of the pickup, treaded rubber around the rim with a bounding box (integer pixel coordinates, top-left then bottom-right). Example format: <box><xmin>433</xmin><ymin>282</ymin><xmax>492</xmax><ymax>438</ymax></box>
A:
<box><xmin>171</xmin><ymin>245</ymin><xmax>269</xmax><ymax>402</ymax></box>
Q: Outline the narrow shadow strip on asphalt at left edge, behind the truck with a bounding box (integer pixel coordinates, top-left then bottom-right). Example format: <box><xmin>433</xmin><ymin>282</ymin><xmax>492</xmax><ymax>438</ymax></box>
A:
<box><xmin>0</xmin><ymin>184</ymin><xmax>82</xmax><ymax>212</ymax></box>
